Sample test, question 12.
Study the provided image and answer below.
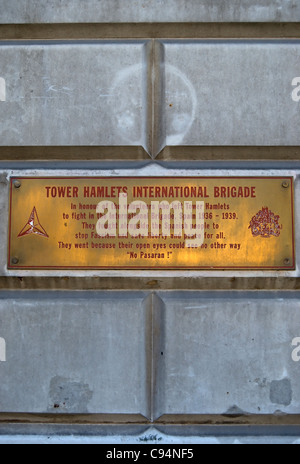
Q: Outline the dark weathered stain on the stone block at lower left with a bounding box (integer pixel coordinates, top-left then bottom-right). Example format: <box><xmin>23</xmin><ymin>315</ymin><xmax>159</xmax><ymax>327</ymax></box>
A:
<box><xmin>48</xmin><ymin>377</ymin><xmax>93</xmax><ymax>414</ymax></box>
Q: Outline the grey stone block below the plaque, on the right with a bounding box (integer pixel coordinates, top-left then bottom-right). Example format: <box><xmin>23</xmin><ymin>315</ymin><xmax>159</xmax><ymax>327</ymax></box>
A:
<box><xmin>155</xmin><ymin>293</ymin><xmax>300</xmax><ymax>417</ymax></box>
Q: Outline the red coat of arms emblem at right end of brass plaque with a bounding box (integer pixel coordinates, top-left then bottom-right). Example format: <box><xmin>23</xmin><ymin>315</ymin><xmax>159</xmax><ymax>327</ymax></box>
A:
<box><xmin>249</xmin><ymin>207</ymin><xmax>282</xmax><ymax>238</ymax></box>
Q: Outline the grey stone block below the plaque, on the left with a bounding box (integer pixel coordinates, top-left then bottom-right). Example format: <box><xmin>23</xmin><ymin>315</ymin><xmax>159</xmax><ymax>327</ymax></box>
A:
<box><xmin>0</xmin><ymin>292</ymin><xmax>150</xmax><ymax>416</ymax></box>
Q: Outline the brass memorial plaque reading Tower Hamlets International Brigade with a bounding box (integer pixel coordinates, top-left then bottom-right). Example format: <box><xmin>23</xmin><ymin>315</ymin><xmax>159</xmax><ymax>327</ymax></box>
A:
<box><xmin>8</xmin><ymin>177</ymin><xmax>295</xmax><ymax>270</ymax></box>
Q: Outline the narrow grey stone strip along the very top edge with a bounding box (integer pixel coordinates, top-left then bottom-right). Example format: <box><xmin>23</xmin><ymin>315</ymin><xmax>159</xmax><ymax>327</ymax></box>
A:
<box><xmin>1</xmin><ymin>0</ymin><xmax>300</xmax><ymax>23</ymax></box>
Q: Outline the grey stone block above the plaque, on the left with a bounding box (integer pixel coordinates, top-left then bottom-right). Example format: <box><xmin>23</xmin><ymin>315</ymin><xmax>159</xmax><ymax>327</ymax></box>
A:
<box><xmin>0</xmin><ymin>41</ymin><xmax>147</xmax><ymax>149</ymax></box>
